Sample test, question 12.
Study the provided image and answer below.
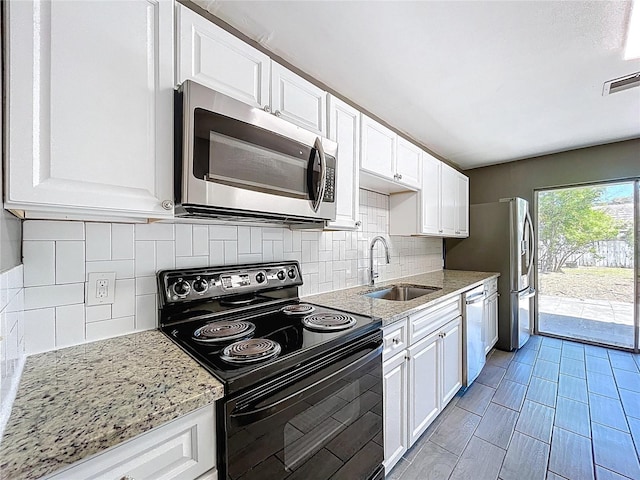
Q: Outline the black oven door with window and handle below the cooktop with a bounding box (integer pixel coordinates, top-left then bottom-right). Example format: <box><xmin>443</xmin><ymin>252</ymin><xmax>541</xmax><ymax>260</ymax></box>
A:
<box><xmin>217</xmin><ymin>332</ymin><xmax>384</xmax><ymax>480</ymax></box>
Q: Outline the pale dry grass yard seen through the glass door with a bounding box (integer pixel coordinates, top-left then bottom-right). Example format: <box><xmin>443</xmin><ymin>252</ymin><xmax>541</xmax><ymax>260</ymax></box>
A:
<box><xmin>538</xmin><ymin>267</ymin><xmax>634</xmax><ymax>303</ymax></box>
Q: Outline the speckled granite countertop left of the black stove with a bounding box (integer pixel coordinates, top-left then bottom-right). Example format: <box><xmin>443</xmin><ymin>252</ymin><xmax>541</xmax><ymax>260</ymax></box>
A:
<box><xmin>0</xmin><ymin>330</ymin><xmax>223</xmax><ymax>479</ymax></box>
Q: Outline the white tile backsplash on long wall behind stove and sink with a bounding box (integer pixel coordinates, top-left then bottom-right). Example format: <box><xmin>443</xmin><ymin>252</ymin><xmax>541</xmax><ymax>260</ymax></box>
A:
<box><xmin>18</xmin><ymin>190</ymin><xmax>443</xmax><ymax>354</ymax></box>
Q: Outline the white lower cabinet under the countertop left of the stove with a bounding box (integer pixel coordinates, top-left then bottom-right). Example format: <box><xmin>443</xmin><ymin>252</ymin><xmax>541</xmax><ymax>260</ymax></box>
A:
<box><xmin>47</xmin><ymin>405</ymin><xmax>218</xmax><ymax>480</ymax></box>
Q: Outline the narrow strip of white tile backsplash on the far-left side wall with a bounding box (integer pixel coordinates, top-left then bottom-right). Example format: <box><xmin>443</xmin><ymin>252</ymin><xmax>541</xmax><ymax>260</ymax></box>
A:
<box><xmin>0</xmin><ymin>265</ymin><xmax>25</xmax><ymax>437</ymax></box>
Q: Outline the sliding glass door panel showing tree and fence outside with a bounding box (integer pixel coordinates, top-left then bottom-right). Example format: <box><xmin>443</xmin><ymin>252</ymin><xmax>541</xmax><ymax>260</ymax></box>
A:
<box><xmin>536</xmin><ymin>180</ymin><xmax>639</xmax><ymax>350</ymax></box>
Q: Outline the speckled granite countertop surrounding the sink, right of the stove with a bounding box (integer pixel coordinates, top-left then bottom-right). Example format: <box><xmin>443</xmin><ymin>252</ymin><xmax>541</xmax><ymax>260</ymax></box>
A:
<box><xmin>303</xmin><ymin>270</ymin><xmax>500</xmax><ymax>326</ymax></box>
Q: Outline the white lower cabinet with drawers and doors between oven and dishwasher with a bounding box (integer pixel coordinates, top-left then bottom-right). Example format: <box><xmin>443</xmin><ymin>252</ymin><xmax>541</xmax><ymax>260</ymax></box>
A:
<box><xmin>382</xmin><ymin>296</ymin><xmax>462</xmax><ymax>473</ymax></box>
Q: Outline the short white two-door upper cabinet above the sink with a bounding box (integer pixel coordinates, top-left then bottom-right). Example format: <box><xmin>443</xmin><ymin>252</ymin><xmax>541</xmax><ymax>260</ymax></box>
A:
<box><xmin>360</xmin><ymin>115</ymin><xmax>422</xmax><ymax>193</ymax></box>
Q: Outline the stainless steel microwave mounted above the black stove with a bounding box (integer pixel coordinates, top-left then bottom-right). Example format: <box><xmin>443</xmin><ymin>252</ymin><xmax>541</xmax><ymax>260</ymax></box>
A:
<box><xmin>175</xmin><ymin>80</ymin><xmax>338</xmax><ymax>223</ymax></box>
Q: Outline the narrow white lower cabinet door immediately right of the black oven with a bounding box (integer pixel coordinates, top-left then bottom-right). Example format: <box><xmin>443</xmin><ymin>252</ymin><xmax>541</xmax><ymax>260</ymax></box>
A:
<box><xmin>382</xmin><ymin>352</ymin><xmax>407</xmax><ymax>472</ymax></box>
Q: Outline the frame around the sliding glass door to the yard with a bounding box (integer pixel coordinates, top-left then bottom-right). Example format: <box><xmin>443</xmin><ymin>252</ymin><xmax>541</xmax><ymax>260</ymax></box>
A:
<box><xmin>533</xmin><ymin>177</ymin><xmax>640</xmax><ymax>353</ymax></box>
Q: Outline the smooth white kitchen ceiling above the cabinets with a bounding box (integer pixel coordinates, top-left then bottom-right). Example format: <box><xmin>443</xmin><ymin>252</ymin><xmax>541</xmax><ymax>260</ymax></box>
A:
<box><xmin>197</xmin><ymin>0</ymin><xmax>640</xmax><ymax>169</ymax></box>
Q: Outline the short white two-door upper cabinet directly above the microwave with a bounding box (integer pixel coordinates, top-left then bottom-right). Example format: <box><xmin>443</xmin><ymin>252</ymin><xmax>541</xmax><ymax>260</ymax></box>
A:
<box><xmin>176</xmin><ymin>4</ymin><xmax>327</xmax><ymax>136</ymax></box>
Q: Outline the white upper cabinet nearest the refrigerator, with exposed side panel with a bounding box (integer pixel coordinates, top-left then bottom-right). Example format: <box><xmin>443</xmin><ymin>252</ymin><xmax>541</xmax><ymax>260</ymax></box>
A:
<box><xmin>389</xmin><ymin>152</ymin><xmax>469</xmax><ymax>237</ymax></box>
